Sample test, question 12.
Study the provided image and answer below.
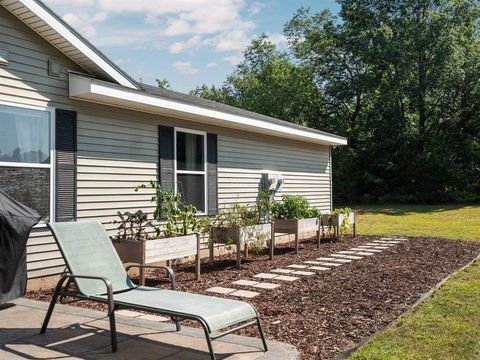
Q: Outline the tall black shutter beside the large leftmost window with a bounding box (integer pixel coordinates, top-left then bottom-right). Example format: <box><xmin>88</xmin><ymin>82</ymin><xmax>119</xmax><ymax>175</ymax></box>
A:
<box><xmin>55</xmin><ymin>109</ymin><xmax>77</xmax><ymax>222</ymax></box>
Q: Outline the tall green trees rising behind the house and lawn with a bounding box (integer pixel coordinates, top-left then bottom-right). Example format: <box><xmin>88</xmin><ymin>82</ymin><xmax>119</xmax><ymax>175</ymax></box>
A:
<box><xmin>191</xmin><ymin>0</ymin><xmax>480</xmax><ymax>203</ymax></box>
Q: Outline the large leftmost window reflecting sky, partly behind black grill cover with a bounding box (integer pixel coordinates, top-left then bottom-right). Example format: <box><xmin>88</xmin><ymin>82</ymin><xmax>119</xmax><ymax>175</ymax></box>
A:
<box><xmin>0</xmin><ymin>102</ymin><xmax>54</xmax><ymax>221</ymax></box>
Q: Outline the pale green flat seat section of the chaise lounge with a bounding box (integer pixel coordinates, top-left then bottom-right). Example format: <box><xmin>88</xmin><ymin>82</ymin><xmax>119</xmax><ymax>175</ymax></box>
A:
<box><xmin>96</xmin><ymin>286</ymin><xmax>257</xmax><ymax>332</ymax></box>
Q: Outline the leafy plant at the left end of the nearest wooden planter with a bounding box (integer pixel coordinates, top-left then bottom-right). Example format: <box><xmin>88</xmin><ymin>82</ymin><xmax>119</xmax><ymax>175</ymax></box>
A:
<box><xmin>113</xmin><ymin>210</ymin><xmax>153</xmax><ymax>242</ymax></box>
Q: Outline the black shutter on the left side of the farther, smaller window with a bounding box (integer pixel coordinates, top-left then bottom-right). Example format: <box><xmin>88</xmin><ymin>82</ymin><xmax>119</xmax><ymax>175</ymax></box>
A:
<box><xmin>158</xmin><ymin>125</ymin><xmax>175</xmax><ymax>191</ymax></box>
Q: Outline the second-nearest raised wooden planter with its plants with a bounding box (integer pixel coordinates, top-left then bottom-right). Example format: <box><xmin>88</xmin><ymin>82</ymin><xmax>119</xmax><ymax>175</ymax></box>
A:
<box><xmin>209</xmin><ymin>194</ymin><xmax>275</xmax><ymax>269</ymax></box>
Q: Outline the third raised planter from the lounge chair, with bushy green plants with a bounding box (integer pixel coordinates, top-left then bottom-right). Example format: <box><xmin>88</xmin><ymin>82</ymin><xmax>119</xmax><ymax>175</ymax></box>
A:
<box><xmin>272</xmin><ymin>195</ymin><xmax>321</xmax><ymax>254</ymax></box>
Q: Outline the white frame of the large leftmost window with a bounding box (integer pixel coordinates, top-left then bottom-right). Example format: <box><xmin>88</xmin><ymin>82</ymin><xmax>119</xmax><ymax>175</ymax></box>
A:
<box><xmin>0</xmin><ymin>100</ymin><xmax>56</xmax><ymax>227</ymax></box>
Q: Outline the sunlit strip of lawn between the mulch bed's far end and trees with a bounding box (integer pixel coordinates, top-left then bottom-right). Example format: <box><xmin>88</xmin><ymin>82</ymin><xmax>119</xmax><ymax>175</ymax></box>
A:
<box><xmin>357</xmin><ymin>205</ymin><xmax>480</xmax><ymax>241</ymax></box>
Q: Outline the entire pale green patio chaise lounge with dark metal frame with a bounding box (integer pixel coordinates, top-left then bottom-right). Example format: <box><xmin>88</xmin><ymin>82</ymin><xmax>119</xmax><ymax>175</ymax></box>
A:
<box><xmin>40</xmin><ymin>222</ymin><xmax>267</xmax><ymax>359</ymax></box>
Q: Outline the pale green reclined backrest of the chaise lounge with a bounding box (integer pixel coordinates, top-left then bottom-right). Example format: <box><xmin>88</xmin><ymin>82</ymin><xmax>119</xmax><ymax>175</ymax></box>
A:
<box><xmin>48</xmin><ymin>222</ymin><xmax>135</xmax><ymax>296</ymax></box>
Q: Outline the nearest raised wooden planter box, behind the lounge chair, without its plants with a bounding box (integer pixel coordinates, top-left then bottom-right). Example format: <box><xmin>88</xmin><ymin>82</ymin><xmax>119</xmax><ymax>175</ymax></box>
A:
<box><xmin>113</xmin><ymin>234</ymin><xmax>200</xmax><ymax>285</ymax></box>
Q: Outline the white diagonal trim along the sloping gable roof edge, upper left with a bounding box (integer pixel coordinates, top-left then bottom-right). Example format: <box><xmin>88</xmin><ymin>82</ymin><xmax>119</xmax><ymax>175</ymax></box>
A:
<box><xmin>17</xmin><ymin>0</ymin><xmax>139</xmax><ymax>89</ymax></box>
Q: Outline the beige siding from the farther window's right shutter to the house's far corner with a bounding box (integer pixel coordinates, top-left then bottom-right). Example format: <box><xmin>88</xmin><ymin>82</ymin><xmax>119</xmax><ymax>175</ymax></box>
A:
<box><xmin>218</xmin><ymin>135</ymin><xmax>330</xmax><ymax>211</ymax></box>
